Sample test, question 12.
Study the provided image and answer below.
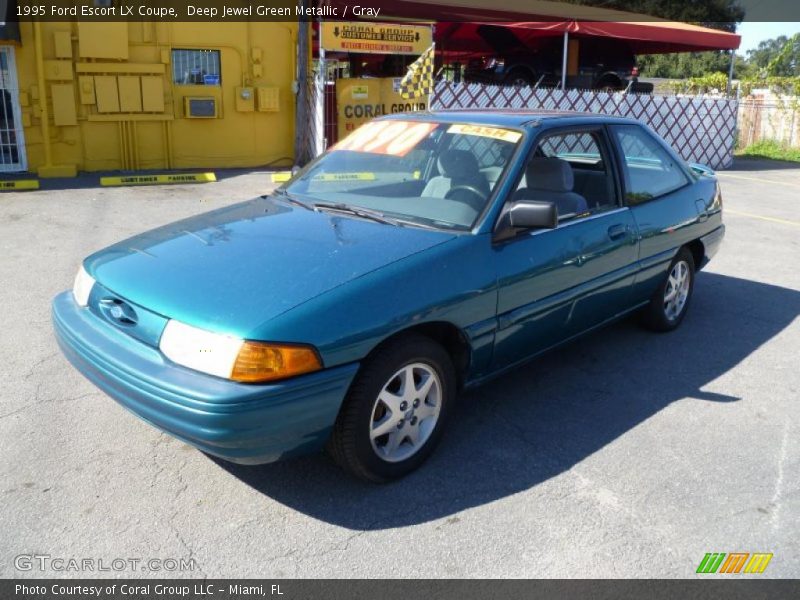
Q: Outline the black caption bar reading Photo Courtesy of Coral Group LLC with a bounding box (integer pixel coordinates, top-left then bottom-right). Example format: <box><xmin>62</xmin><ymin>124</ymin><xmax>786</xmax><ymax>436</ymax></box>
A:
<box><xmin>0</xmin><ymin>575</ymin><xmax>800</xmax><ymax>600</ymax></box>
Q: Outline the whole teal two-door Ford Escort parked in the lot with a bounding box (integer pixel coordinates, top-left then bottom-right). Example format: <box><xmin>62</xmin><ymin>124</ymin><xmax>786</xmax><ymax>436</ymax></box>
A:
<box><xmin>53</xmin><ymin>111</ymin><xmax>724</xmax><ymax>481</ymax></box>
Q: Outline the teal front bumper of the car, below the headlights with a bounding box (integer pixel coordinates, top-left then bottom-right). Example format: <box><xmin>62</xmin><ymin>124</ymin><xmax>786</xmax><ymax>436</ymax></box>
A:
<box><xmin>53</xmin><ymin>292</ymin><xmax>358</xmax><ymax>464</ymax></box>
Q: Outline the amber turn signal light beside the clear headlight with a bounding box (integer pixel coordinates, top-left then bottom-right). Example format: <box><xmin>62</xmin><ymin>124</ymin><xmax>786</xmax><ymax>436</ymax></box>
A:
<box><xmin>230</xmin><ymin>341</ymin><xmax>322</xmax><ymax>383</ymax></box>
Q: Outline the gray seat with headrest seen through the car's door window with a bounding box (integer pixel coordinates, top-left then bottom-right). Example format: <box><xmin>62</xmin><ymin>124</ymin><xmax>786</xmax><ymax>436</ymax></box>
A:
<box><xmin>514</xmin><ymin>156</ymin><xmax>589</xmax><ymax>217</ymax></box>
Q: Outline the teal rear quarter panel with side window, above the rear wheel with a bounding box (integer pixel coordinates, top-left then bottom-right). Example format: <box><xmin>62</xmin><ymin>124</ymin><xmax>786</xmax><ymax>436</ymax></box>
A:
<box><xmin>610</xmin><ymin>124</ymin><xmax>707</xmax><ymax>302</ymax></box>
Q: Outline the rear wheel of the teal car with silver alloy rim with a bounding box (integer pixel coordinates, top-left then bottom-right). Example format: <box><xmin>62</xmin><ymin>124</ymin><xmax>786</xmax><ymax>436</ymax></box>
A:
<box><xmin>642</xmin><ymin>248</ymin><xmax>695</xmax><ymax>332</ymax></box>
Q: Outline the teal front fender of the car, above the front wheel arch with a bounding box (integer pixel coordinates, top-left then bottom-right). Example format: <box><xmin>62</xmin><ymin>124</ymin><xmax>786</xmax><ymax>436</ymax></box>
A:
<box><xmin>256</xmin><ymin>234</ymin><xmax>497</xmax><ymax>380</ymax></box>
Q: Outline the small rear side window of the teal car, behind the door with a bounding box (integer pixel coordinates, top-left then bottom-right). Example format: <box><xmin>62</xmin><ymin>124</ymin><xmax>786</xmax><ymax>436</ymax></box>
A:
<box><xmin>613</xmin><ymin>125</ymin><xmax>689</xmax><ymax>205</ymax></box>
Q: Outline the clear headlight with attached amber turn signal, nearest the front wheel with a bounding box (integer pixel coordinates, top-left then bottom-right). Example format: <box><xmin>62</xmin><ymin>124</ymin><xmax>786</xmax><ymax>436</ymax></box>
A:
<box><xmin>159</xmin><ymin>319</ymin><xmax>322</xmax><ymax>383</ymax></box>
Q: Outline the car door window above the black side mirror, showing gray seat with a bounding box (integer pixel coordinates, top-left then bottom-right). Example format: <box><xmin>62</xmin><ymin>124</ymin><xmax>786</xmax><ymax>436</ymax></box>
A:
<box><xmin>513</xmin><ymin>131</ymin><xmax>618</xmax><ymax>223</ymax></box>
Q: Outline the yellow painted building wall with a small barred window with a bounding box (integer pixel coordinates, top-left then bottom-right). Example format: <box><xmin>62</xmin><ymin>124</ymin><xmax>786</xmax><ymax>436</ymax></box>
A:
<box><xmin>11</xmin><ymin>22</ymin><xmax>297</xmax><ymax>175</ymax></box>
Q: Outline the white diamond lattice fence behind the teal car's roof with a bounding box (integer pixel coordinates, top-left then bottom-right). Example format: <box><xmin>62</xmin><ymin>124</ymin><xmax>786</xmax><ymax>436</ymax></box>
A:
<box><xmin>431</xmin><ymin>81</ymin><xmax>738</xmax><ymax>169</ymax></box>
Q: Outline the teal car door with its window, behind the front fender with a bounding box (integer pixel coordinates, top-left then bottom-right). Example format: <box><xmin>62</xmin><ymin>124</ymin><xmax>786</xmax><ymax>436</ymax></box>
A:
<box><xmin>493</xmin><ymin>126</ymin><xmax>638</xmax><ymax>370</ymax></box>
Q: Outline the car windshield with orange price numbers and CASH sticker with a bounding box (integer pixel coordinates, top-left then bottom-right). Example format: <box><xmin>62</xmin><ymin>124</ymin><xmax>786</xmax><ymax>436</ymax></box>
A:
<box><xmin>281</xmin><ymin>120</ymin><xmax>522</xmax><ymax>230</ymax></box>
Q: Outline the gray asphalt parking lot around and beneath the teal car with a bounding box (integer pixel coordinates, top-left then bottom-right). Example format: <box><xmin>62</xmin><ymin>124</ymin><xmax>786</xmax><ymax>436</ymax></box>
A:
<box><xmin>0</xmin><ymin>161</ymin><xmax>800</xmax><ymax>578</ymax></box>
